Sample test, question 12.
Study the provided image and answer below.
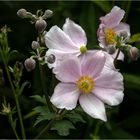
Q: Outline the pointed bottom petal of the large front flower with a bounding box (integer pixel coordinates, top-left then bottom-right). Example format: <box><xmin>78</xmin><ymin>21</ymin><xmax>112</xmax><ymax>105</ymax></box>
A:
<box><xmin>79</xmin><ymin>94</ymin><xmax>107</xmax><ymax>121</ymax></box>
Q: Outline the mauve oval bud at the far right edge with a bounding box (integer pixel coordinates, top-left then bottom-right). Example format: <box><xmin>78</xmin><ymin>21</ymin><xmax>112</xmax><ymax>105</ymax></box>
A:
<box><xmin>128</xmin><ymin>47</ymin><xmax>139</xmax><ymax>60</ymax></box>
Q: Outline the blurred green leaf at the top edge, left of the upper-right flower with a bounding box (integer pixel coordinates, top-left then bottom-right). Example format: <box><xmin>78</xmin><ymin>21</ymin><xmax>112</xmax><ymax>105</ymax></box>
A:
<box><xmin>91</xmin><ymin>0</ymin><xmax>111</xmax><ymax>13</ymax></box>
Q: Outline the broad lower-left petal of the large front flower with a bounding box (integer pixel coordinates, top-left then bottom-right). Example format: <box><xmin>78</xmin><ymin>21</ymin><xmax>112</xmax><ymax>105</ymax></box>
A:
<box><xmin>51</xmin><ymin>83</ymin><xmax>80</xmax><ymax>110</ymax></box>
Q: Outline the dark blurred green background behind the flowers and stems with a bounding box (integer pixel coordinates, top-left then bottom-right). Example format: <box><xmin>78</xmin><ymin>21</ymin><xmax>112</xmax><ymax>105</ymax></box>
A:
<box><xmin>0</xmin><ymin>0</ymin><xmax>140</xmax><ymax>139</ymax></box>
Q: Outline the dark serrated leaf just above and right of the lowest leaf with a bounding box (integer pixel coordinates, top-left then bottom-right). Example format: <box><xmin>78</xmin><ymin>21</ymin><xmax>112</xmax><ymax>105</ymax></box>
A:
<box><xmin>65</xmin><ymin>112</ymin><xmax>85</xmax><ymax>123</ymax></box>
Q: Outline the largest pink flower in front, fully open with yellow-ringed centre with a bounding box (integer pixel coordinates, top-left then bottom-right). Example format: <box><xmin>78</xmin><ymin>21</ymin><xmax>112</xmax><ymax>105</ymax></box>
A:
<box><xmin>51</xmin><ymin>51</ymin><xmax>124</xmax><ymax>121</ymax></box>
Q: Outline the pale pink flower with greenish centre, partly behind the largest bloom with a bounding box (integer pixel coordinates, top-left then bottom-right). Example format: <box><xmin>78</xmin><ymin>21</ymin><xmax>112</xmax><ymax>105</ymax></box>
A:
<box><xmin>45</xmin><ymin>18</ymin><xmax>87</xmax><ymax>68</ymax></box>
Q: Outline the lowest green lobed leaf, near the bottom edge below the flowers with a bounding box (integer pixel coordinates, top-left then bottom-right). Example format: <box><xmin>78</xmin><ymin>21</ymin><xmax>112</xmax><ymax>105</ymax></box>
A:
<box><xmin>51</xmin><ymin>120</ymin><xmax>75</xmax><ymax>136</ymax></box>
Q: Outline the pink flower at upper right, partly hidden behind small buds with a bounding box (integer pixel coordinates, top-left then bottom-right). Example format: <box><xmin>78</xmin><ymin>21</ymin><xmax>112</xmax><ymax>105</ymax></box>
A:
<box><xmin>97</xmin><ymin>6</ymin><xmax>130</xmax><ymax>60</ymax></box>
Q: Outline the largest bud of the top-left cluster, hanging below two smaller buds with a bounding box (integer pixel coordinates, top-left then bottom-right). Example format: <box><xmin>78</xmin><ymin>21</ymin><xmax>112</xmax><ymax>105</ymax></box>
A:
<box><xmin>35</xmin><ymin>19</ymin><xmax>47</xmax><ymax>33</ymax></box>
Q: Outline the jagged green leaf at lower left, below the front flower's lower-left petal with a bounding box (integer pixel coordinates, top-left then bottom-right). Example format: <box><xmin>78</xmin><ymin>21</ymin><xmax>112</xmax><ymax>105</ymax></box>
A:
<box><xmin>33</xmin><ymin>106</ymin><xmax>56</xmax><ymax>126</ymax></box>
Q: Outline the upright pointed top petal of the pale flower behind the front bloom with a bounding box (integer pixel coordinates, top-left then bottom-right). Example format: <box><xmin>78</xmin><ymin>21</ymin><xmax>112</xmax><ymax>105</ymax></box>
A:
<box><xmin>63</xmin><ymin>18</ymin><xmax>87</xmax><ymax>48</ymax></box>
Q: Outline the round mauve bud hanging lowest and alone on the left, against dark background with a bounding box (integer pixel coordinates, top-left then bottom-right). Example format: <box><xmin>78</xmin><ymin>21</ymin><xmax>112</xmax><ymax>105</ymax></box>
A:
<box><xmin>24</xmin><ymin>58</ymin><xmax>36</xmax><ymax>71</ymax></box>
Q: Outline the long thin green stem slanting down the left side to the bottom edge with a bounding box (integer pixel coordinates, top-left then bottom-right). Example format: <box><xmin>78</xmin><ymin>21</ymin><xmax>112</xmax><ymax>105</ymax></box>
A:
<box><xmin>1</xmin><ymin>53</ymin><xmax>26</xmax><ymax>139</ymax></box>
